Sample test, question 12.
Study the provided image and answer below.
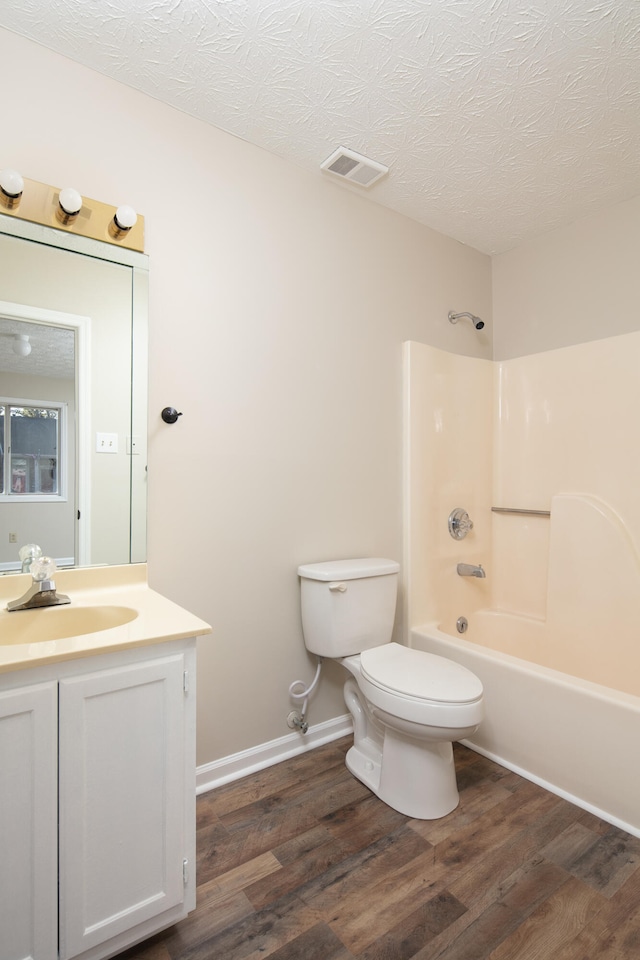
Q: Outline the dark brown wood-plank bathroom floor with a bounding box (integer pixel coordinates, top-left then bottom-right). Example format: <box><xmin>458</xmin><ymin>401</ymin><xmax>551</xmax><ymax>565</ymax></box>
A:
<box><xmin>121</xmin><ymin>738</ymin><xmax>640</xmax><ymax>960</ymax></box>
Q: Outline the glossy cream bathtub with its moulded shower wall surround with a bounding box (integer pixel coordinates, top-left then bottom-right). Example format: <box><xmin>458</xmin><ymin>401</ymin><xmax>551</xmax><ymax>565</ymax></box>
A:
<box><xmin>404</xmin><ymin>333</ymin><xmax>640</xmax><ymax>833</ymax></box>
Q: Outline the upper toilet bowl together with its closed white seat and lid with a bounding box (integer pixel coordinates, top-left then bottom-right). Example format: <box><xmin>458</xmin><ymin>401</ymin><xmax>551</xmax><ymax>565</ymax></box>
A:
<box><xmin>352</xmin><ymin>643</ymin><xmax>483</xmax><ymax>728</ymax></box>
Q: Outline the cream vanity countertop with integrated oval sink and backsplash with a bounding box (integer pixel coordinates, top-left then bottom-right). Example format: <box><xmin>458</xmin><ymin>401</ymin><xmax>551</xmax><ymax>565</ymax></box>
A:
<box><xmin>0</xmin><ymin>563</ymin><xmax>211</xmax><ymax>673</ymax></box>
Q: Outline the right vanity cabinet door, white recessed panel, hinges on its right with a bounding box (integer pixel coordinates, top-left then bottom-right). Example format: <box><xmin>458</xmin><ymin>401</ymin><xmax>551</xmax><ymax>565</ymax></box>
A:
<box><xmin>59</xmin><ymin>655</ymin><xmax>185</xmax><ymax>960</ymax></box>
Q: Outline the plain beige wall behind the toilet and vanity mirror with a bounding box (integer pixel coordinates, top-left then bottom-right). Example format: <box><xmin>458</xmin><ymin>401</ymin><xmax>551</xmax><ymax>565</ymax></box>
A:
<box><xmin>0</xmin><ymin>31</ymin><xmax>492</xmax><ymax>764</ymax></box>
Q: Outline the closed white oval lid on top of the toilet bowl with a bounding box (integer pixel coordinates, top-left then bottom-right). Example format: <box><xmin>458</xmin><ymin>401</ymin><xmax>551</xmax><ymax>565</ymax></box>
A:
<box><xmin>360</xmin><ymin>643</ymin><xmax>482</xmax><ymax>703</ymax></box>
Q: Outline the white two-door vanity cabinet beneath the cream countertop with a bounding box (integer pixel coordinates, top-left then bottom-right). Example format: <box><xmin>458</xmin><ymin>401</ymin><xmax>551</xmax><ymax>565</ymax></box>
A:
<box><xmin>0</xmin><ymin>636</ymin><xmax>195</xmax><ymax>960</ymax></box>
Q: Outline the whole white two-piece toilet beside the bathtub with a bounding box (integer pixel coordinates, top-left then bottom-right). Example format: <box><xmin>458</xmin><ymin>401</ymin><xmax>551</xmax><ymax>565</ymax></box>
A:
<box><xmin>298</xmin><ymin>557</ymin><xmax>483</xmax><ymax>820</ymax></box>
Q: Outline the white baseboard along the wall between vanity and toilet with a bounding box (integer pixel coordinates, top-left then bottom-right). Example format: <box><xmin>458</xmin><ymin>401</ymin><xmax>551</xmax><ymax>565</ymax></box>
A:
<box><xmin>196</xmin><ymin>714</ymin><xmax>353</xmax><ymax>794</ymax></box>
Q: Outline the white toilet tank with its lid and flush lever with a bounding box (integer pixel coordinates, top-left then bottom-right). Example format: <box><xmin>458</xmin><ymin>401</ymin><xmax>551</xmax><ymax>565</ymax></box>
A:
<box><xmin>298</xmin><ymin>557</ymin><xmax>400</xmax><ymax>657</ymax></box>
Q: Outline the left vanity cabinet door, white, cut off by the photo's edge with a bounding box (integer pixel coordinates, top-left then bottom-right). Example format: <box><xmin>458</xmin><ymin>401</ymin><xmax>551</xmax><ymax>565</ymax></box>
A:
<box><xmin>0</xmin><ymin>680</ymin><xmax>58</xmax><ymax>960</ymax></box>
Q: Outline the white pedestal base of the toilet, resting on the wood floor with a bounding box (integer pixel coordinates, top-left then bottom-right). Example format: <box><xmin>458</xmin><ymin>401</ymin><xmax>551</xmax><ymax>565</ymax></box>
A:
<box><xmin>346</xmin><ymin>727</ymin><xmax>460</xmax><ymax>820</ymax></box>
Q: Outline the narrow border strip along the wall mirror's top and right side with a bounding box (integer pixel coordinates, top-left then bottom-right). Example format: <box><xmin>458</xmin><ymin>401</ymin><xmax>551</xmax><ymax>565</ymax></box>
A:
<box><xmin>0</xmin><ymin>213</ymin><xmax>149</xmax><ymax>563</ymax></box>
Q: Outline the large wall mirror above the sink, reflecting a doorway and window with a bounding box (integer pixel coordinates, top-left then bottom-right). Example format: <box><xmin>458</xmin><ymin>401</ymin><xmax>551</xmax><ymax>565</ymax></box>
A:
<box><xmin>0</xmin><ymin>215</ymin><xmax>149</xmax><ymax>573</ymax></box>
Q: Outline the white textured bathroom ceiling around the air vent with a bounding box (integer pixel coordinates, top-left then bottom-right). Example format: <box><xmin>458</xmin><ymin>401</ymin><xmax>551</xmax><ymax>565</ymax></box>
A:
<box><xmin>0</xmin><ymin>0</ymin><xmax>640</xmax><ymax>253</ymax></box>
